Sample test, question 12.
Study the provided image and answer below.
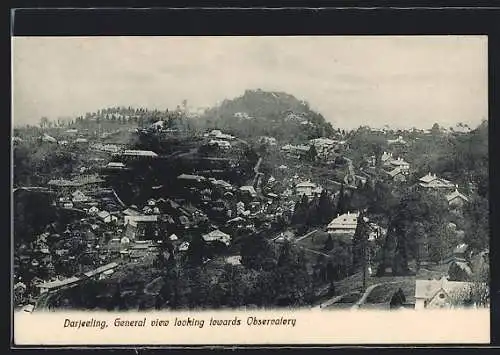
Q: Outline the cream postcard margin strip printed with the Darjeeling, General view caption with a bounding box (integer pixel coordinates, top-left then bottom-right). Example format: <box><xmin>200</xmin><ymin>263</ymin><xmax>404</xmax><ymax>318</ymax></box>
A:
<box><xmin>13</xmin><ymin>309</ymin><xmax>490</xmax><ymax>346</ymax></box>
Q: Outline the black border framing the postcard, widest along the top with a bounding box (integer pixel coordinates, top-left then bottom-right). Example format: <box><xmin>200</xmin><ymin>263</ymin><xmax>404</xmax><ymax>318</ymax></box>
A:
<box><xmin>8</xmin><ymin>5</ymin><xmax>500</xmax><ymax>353</ymax></box>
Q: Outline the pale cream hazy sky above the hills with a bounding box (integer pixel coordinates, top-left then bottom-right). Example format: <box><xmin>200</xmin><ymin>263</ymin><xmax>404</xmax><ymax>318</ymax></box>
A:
<box><xmin>12</xmin><ymin>36</ymin><xmax>488</xmax><ymax>129</ymax></box>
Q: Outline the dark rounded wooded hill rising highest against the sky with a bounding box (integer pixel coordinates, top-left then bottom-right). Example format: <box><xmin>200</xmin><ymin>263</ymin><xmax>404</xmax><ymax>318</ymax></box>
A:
<box><xmin>198</xmin><ymin>89</ymin><xmax>334</xmax><ymax>141</ymax></box>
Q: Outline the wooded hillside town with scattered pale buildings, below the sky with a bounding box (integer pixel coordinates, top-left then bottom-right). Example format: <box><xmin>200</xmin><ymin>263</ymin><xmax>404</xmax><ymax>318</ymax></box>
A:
<box><xmin>12</xmin><ymin>91</ymin><xmax>489</xmax><ymax>312</ymax></box>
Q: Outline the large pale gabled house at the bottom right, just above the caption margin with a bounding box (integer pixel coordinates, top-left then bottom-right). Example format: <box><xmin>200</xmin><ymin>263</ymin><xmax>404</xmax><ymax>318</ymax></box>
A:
<box><xmin>415</xmin><ymin>276</ymin><xmax>471</xmax><ymax>310</ymax></box>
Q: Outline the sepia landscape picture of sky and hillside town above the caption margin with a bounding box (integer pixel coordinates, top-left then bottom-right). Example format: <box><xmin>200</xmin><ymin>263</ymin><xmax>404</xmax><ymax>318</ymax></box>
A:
<box><xmin>11</xmin><ymin>36</ymin><xmax>490</xmax><ymax>340</ymax></box>
